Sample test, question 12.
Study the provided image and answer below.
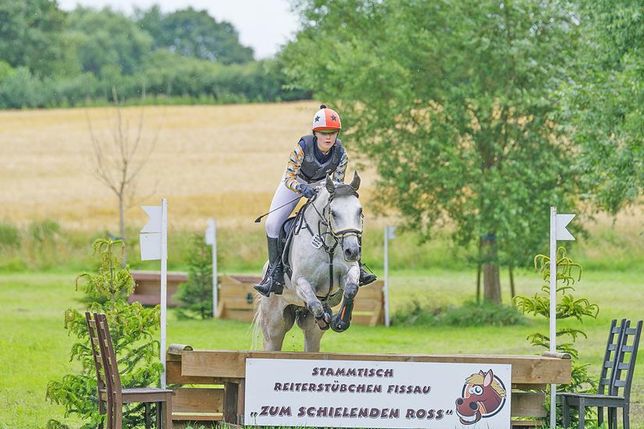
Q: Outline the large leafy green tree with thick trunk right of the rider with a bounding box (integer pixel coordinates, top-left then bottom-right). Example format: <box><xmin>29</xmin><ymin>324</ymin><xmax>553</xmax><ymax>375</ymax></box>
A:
<box><xmin>284</xmin><ymin>0</ymin><xmax>581</xmax><ymax>303</ymax></box>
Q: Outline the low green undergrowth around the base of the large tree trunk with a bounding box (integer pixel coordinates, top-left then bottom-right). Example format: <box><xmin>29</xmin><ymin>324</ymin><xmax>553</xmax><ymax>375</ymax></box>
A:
<box><xmin>393</xmin><ymin>300</ymin><xmax>526</xmax><ymax>326</ymax></box>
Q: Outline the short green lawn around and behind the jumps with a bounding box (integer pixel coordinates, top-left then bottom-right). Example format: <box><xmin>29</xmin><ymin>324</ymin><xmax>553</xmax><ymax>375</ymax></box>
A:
<box><xmin>0</xmin><ymin>270</ymin><xmax>644</xmax><ymax>429</ymax></box>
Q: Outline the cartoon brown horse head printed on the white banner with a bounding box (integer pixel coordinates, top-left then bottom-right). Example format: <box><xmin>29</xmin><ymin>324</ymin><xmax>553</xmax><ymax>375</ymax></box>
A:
<box><xmin>456</xmin><ymin>369</ymin><xmax>506</xmax><ymax>425</ymax></box>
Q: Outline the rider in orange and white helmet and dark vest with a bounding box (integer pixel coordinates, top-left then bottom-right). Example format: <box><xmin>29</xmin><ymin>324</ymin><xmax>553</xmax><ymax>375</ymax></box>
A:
<box><xmin>255</xmin><ymin>104</ymin><xmax>376</xmax><ymax>296</ymax></box>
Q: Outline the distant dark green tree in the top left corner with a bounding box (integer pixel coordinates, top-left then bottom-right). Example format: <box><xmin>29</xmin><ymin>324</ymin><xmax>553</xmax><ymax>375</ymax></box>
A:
<box><xmin>0</xmin><ymin>0</ymin><xmax>65</xmax><ymax>76</ymax></box>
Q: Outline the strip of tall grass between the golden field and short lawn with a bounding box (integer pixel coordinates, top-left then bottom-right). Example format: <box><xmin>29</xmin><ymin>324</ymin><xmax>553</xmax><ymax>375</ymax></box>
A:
<box><xmin>0</xmin><ymin>219</ymin><xmax>644</xmax><ymax>273</ymax></box>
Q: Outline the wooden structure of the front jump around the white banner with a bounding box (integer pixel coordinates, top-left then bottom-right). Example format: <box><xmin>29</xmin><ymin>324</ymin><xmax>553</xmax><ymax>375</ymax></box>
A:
<box><xmin>167</xmin><ymin>344</ymin><xmax>571</xmax><ymax>428</ymax></box>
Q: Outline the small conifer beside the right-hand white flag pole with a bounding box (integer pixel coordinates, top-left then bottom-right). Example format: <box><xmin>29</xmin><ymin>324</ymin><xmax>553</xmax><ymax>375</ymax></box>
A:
<box><xmin>514</xmin><ymin>247</ymin><xmax>599</xmax><ymax>422</ymax></box>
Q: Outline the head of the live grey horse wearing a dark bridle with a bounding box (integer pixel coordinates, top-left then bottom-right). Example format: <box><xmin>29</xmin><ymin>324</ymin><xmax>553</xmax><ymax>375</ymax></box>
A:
<box><xmin>324</xmin><ymin>173</ymin><xmax>362</xmax><ymax>262</ymax></box>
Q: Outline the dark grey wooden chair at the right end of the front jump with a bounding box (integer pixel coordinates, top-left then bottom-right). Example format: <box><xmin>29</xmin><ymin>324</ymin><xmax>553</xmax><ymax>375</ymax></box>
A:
<box><xmin>557</xmin><ymin>320</ymin><xmax>642</xmax><ymax>429</ymax></box>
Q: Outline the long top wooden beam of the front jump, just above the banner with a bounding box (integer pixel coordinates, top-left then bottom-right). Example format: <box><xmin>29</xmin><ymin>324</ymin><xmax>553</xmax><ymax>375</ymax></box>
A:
<box><xmin>181</xmin><ymin>350</ymin><xmax>571</xmax><ymax>384</ymax></box>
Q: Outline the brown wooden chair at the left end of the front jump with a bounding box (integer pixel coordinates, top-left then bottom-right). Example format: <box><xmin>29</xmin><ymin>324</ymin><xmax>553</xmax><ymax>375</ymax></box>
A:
<box><xmin>85</xmin><ymin>313</ymin><xmax>172</xmax><ymax>429</ymax></box>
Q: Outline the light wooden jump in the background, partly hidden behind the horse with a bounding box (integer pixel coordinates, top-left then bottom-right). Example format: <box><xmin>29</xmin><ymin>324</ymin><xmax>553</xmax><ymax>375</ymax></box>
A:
<box><xmin>217</xmin><ymin>276</ymin><xmax>385</xmax><ymax>326</ymax></box>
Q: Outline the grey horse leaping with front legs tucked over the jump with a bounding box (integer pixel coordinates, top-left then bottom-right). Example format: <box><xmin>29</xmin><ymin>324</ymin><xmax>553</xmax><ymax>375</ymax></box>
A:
<box><xmin>254</xmin><ymin>173</ymin><xmax>362</xmax><ymax>352</ymax></box>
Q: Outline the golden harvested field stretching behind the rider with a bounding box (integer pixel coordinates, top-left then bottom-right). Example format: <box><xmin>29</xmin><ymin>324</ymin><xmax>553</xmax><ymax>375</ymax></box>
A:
<box><xmin>0</xmin><ymin>101</ymin><xmax>380</xmax><ymax>229</ymax></box>
